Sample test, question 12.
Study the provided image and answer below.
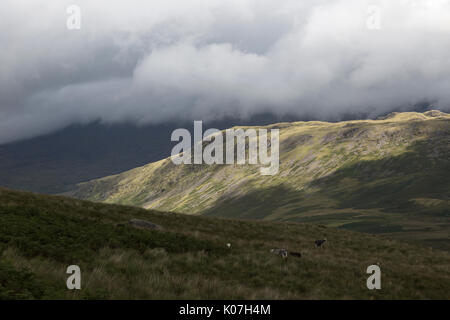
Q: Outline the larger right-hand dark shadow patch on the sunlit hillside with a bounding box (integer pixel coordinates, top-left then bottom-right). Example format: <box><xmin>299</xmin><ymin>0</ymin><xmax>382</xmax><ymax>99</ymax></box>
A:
<box><xmin>310</xmin><ymin>139</ymin><xmax>450</xmax><ymax>213</ymax></box>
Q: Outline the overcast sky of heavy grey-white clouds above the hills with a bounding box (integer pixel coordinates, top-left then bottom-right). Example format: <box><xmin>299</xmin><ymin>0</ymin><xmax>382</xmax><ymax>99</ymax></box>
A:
<box><xmin>0</xmin><ymin>0</ymin><xmax>450</xmax><ymax>143</ymax></box>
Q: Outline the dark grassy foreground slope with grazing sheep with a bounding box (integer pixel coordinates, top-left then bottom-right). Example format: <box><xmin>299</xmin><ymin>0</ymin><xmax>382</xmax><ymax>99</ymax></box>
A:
<box><xmin>0</xmin><ymin>188</ymin><xmax>450</xmax><ymax>299</ymax></box>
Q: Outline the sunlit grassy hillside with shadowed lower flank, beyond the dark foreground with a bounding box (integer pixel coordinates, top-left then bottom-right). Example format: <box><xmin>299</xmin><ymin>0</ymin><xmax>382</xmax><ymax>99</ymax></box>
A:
<box><xmin>68</xmin><ymin>111</ymin><xmax>450</xmax><ymax>249</ymax></box>
